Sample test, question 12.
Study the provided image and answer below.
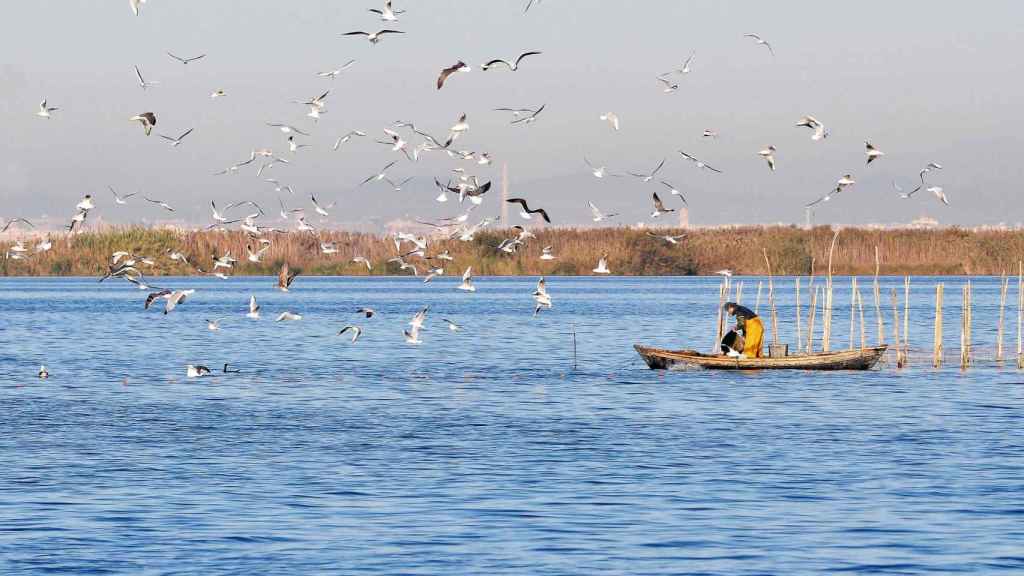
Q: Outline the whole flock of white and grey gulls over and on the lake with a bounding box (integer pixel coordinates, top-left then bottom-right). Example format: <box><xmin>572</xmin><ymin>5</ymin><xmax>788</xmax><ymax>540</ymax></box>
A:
<box><xmin>8</xmin><ymin>0</ymin><xmax>949</xmax><ymax>376</ymax></box>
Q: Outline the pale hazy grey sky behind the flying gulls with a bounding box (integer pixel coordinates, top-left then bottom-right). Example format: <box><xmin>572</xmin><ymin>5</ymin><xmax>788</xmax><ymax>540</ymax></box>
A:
<box><xmin>0</xmin><ymin>0</ymin><xmax>1024</xmax><ymax>227</ymax></box>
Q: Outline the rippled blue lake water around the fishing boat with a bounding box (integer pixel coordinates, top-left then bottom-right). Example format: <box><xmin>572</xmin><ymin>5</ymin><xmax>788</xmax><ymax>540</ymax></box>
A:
<box><xmin>0</xmin><ymin>277</ymin><xmax>1024</xmax><ymax>575</ymax></box>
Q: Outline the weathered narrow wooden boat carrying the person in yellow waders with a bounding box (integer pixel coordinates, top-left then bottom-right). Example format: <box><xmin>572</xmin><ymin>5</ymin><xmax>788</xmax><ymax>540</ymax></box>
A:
<box><xmin>633</xmin><ymin>344</ymin><xmax>889</xmax><ymax>370</ymax></box>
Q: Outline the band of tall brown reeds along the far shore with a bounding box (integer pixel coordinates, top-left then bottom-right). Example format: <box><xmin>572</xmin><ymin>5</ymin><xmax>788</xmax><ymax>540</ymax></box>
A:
<box><xmin>0</xmin><ymin>227</ymin><xmax>1024</xmax><ymax>276</ymax></box>
